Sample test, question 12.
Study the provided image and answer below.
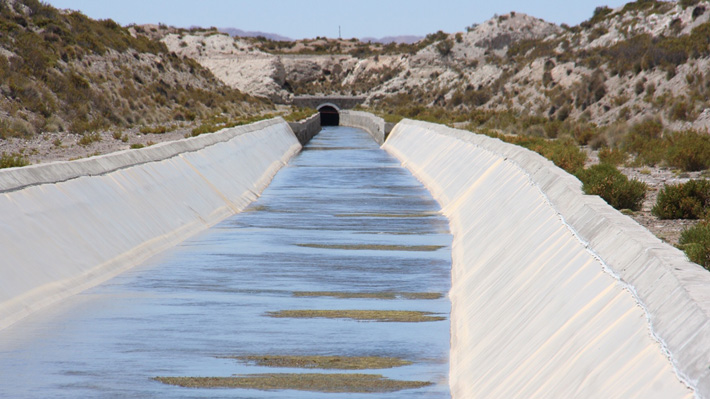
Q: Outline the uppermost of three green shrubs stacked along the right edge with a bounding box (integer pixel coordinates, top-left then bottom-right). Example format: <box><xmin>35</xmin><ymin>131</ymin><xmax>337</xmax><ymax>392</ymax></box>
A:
<box><xmin>666</xmin><ymin>130</ymin><xmax>710</xmax><ymax>171</ymax></box>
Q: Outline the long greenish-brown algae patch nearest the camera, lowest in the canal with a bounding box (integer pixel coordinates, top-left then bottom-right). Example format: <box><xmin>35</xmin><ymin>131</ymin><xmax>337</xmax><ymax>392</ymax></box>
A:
<box><xmin>154</xmin><ymin>374</ymin><xmax>432</xmax><ymax>393</ymax></box>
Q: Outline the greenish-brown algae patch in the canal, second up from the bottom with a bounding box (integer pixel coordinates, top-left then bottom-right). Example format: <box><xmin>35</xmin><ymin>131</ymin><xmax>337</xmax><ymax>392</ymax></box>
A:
<box><xmin>231</xmin><ymin>355</ymin><xmax>412</xmax><ymax>370</ymax></box>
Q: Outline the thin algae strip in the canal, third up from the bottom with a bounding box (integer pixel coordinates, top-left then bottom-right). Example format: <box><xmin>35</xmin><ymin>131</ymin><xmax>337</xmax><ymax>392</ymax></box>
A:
<box><xmin>266</xmin><ymin>310</ymin><xmax>446</xmax><ymax>323</ymax></box>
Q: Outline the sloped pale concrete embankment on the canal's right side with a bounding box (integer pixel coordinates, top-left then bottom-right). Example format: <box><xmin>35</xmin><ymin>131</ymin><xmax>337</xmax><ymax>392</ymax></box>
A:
<box><xmin>383</xmin><ymin>120</ymin><xmax>710</xmax><ymax>398</ymax></box>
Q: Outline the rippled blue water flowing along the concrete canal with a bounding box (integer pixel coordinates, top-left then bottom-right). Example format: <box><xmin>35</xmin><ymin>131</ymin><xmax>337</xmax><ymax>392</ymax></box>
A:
<box><xmin>0</xmin><ymin>127</ymin><xmax>451</xmax><ymax>398</ymax></box>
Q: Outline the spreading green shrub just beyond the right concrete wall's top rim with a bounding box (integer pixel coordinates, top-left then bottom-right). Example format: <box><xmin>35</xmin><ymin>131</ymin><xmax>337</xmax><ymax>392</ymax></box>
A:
<box><xmin>577</xmin><ymin>163</ymin><xmax>647</xmax><ymax>211</ymax></box>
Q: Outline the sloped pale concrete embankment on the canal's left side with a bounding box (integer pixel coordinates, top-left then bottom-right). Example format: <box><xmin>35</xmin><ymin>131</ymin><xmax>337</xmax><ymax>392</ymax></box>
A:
<box><xmin>0</xmin><ymin>118</ymin><xmax>301</xmax><ymax>328</ymax></box>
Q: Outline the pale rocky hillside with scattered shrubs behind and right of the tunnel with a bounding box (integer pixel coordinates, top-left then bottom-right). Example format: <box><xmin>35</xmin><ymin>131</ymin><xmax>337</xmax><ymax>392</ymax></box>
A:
<box><xmin>163</xmin><ymin>0</ymin><xmax>710</xmax><ymax>136</ymax></box>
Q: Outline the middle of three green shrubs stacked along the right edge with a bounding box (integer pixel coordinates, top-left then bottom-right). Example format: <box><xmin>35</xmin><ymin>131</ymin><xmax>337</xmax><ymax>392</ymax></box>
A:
<box><xmin>651</xmin><ymin>180</ymin><xmax>710</xmax><ymax>219</ymax></box>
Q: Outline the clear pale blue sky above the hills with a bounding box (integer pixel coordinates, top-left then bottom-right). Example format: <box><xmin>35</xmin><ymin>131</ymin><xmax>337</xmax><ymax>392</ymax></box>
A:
<box><xmin>46</xmin><ymin>0</ymin><xmax>627</xmax><ymax>39</ymax></box>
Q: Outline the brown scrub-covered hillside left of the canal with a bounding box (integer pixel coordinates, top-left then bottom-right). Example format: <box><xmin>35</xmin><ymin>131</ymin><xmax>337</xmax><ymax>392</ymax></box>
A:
<box><xmin>0</xmin><ymin>0</ymin><xmax>270</xmax><ymax>138</ymax></box>
